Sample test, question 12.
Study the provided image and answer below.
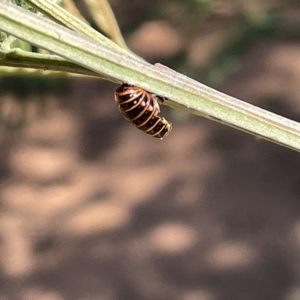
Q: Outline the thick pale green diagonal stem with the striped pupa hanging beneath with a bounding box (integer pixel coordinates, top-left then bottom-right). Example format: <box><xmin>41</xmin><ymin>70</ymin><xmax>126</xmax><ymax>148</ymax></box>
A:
<box><xmin>0</xmin><ymin>0</ymin><xmax>300</xmax><ymax>151</ymax></box>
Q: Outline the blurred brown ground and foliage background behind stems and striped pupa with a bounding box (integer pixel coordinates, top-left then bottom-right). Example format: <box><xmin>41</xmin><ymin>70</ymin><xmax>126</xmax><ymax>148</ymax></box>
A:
<box><xmin>0</xmin><ymin>0</ymin><xmax>300</xmax><ymax>300</ymax></box>
